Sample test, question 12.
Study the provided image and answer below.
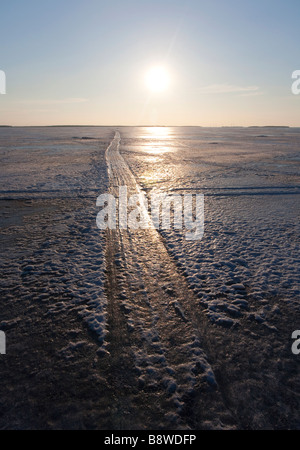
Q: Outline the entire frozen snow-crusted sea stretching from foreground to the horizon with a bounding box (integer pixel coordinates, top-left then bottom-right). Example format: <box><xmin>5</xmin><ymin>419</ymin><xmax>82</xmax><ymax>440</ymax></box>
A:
<box><xmin>0</xmin><ymin>127</ymin><xmax>300</xmax><ymax>430</ymax></box>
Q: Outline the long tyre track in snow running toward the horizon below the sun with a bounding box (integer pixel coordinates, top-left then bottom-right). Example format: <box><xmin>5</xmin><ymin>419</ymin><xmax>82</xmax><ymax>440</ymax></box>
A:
<box><xmin>106</xmin><ymin>132</ymin><xmax>234</xmax><ymax>428</ymax></box>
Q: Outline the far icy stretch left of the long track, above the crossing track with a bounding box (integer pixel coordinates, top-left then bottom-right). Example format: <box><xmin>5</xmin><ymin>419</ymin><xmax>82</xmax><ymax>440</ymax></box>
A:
<box><xmin>0</xmin><ymin>127</ymin><xmax>114</xmax><ymax>198</ymax></box>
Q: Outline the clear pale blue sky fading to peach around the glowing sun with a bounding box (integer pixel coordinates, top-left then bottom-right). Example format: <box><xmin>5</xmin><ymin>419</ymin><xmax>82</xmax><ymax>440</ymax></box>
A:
<box><xmin>0</xmin><ymin>0</ymin><xmax>300</xmax><ymax>126</ymax></box>
